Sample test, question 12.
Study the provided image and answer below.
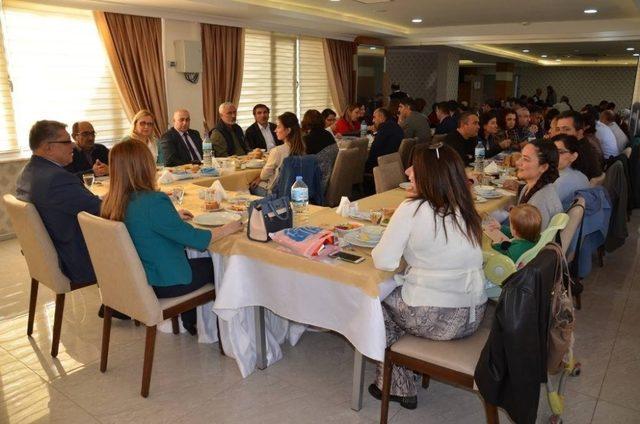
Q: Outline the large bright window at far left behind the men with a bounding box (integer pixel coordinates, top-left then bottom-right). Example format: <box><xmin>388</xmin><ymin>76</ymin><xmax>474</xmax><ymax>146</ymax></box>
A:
<box><xmin>0</xmin><ymin>1</ymin><xmax>129</xmax><ymax>149</ymax></box>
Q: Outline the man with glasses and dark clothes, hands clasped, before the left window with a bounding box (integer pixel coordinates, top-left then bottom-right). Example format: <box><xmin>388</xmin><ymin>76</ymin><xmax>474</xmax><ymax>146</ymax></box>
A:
<box><xmin>64</xmin><ymin>121</ymin><xmax>109</xmax><ymax>177</ymax></box>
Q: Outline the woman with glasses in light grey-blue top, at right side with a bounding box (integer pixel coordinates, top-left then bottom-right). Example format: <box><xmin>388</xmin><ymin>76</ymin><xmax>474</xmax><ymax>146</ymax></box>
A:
<box><xmin>551</xmin><ymin>134</ymin><xmax>589</xmax><ymax>210</ymax></box>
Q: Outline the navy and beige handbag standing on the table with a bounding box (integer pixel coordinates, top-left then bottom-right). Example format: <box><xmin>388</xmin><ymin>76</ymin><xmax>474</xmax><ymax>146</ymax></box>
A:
<box><xmin>247</xmin><ymin>195</ymin><xmax>293</xmax><ymax>243</ymax></box>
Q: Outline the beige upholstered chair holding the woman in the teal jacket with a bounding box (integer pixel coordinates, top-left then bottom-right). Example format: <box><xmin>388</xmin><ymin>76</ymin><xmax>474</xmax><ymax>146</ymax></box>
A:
<box><xmin>78</xmin><ymin>212</ymin><xmax>215</xmax><ymax>397</ymax></box>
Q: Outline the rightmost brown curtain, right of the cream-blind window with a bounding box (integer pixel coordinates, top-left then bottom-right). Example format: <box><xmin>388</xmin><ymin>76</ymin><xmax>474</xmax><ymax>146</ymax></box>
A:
<box><xmin>322</xmin><ymin>38</ymin><xmax>358</xmax><ymax>116</ymax></box>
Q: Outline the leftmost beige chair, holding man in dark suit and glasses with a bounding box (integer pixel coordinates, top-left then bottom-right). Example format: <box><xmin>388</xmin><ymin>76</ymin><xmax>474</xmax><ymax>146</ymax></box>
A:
<box><xmin>3</xmin><ymin>194</ymin><xmax>95</xmax><ymax>357</ymax></box>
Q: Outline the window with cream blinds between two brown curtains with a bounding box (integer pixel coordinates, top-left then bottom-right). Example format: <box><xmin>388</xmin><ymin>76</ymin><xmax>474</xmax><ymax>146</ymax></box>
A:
<box><xmin>238</xmin><ymin>30</ymin><xmax>332</xmax><ymax>128</ymax></box>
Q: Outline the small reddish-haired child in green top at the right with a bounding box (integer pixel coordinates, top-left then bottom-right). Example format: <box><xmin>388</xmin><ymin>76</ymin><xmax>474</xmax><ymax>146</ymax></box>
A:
<box><xmin>491</xmin><ymin>203</ymin><xmax>542</xmax><ymax>262</ymax></box>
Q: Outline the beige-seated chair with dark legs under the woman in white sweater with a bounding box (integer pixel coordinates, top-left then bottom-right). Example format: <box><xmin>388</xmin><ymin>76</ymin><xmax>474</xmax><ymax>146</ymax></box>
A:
<box><xmin>380</xmin><ymin>311</ymin><xmax>499</xmax><ymax>424</ymax></box>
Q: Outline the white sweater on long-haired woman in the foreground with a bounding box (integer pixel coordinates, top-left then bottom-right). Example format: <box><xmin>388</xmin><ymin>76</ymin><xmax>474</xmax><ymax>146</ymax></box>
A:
<box><xmin>371</xmin><ymin>200</ymin><xmax>487</xmax><ymax>322</ymax></box>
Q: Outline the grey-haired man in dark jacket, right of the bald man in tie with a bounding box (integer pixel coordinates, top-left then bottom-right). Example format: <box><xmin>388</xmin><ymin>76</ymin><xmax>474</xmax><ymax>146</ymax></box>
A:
<box><xmin>210</xmin><ymin>102</ymin><xmax>249</xmax><ymax>157</ymax></box>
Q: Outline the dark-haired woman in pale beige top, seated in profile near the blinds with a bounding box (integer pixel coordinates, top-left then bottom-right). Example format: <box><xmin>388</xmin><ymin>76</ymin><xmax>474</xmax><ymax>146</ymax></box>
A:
<box><xmin>250</xmin><ymin>112</ymin><xmax>305</xmax><ymax>196</ymax></box>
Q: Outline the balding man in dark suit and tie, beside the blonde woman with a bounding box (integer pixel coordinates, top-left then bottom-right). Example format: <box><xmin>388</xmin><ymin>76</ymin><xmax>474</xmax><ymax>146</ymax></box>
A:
<box><xmin>159</xmin><ymin>109</ymin><xmax>203</xmax><ymax>166</ymax></box>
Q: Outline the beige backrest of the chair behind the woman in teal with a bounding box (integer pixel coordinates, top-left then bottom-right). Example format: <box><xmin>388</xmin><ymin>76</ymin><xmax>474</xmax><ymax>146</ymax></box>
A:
<box><xmin>78</xmin><ymin>212</ymin><xmax>162</xmax><ymax>326</ymax></box>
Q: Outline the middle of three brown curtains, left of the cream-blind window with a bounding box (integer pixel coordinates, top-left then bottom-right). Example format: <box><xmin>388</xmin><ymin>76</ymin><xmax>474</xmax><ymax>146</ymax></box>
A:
<box><xmin>200</xmin><ymin>24</ymin><xmax>244</xmax><ymax>127</ymax></box>
